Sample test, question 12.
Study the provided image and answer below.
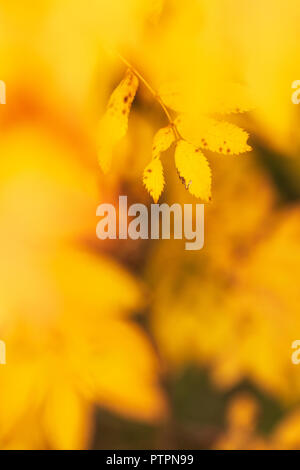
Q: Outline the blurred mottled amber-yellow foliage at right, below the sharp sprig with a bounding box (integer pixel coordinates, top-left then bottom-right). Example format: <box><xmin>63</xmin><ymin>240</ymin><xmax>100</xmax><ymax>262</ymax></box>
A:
<box><xmin>148</xmin><ymin>154</ymin><xmax>300</xmax><ymax>401</ymax></box>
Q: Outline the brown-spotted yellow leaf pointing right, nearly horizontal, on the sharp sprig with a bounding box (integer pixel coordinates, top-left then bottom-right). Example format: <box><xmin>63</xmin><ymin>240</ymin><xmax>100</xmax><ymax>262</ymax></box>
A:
<box><xmin>176</xmin><ymin>114</ymin><xmax>252</xmax><ymax>155</ymax></box>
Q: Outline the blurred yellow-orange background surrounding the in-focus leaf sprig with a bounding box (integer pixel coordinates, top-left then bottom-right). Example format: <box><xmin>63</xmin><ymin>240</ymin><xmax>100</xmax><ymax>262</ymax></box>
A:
<box><xmin>0</xmin><ymin>0</ymin><xmax>300</xmax><ymax>449</ymax></box>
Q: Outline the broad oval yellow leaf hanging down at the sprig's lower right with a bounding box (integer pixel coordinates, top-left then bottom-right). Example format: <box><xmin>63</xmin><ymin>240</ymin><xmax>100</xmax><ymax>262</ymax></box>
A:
<box><xmin>175</xmin><ymin>140</ymin><xmax>211</xmax><ymax>201</ymax></box>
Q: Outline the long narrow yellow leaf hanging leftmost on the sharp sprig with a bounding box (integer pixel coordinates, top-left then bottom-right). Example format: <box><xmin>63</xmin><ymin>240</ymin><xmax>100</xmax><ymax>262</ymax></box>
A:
<box><xmin>98</xmin><ymin>70</ymin><xmax>139</xmax><ymax>173</ymax></box>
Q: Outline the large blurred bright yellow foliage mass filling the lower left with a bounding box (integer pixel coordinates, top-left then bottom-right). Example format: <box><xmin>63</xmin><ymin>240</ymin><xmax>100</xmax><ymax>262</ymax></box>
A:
<box><xmin>0</xmin><ymin>127</ymin><xmax>164</xmax><ymax>449</ymax></box>
